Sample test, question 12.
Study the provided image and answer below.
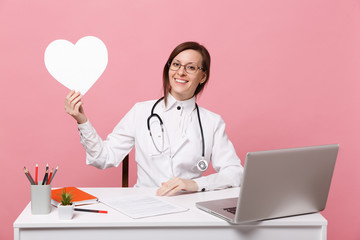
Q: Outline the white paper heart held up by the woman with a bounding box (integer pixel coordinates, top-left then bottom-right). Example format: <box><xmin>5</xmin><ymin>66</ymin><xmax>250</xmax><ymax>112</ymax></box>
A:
<box><xmin>44</xmin><ymin>36</ymin><xmax>108</xmax><ymax>95</ymax></box>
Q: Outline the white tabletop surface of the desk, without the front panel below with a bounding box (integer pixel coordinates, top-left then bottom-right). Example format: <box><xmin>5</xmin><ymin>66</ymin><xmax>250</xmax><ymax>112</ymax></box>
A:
<box><xmin>14</xmin><ymin>188</ymin><xmax>327</xmax><ymax>229</ymax></box>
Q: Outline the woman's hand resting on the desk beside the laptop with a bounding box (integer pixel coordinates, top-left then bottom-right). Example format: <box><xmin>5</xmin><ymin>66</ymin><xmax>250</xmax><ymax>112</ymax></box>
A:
<box><xmin>156</xmin><ymin>177</ymin><xmax>199</xmax><ymax>196</ymax></box>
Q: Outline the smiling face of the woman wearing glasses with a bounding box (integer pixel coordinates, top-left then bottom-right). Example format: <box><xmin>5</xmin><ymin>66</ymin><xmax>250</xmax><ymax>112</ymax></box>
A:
<box><xmin>169</xmin><ymin>49</ymin><xmax>206</xmax><ymax>101</ymax></box>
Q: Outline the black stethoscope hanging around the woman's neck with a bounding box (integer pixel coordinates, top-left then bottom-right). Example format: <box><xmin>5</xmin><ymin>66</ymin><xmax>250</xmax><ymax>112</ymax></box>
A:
<box><xmin>147</xmin><ymin>97</ymin><xmax>209</xmax><ymax>172</ymax></box>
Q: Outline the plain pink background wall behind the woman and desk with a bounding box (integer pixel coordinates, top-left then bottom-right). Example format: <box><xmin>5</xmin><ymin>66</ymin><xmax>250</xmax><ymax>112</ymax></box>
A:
<box><xmin>0</xmin><ymin>0</ymin><xmax>360</xmax><ymax>240</ymax></box>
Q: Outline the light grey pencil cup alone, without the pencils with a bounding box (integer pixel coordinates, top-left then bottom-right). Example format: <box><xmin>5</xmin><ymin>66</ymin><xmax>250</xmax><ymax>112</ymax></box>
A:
<box><xmin>31</xmin><ymin>183</ymin><xmax>51</xmax><ymax>214</ymax></box>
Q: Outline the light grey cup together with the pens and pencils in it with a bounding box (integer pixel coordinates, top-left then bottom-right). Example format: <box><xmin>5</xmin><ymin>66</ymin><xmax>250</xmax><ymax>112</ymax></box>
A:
<box><xmin>24</xmin><ymin>164</ymin><xmax>57</xmax><ymax>214</ymax></box>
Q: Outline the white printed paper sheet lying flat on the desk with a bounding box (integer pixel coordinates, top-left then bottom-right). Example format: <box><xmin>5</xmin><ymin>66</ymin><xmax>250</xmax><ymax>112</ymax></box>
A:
<box><xmin>100</xmin><ymin>195</ymin><xmax>188</xmax><ymax>218</ymax></box>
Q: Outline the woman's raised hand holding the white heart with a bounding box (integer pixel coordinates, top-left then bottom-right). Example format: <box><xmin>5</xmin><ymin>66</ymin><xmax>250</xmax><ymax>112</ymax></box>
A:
<box><xmin>65</xmin><ymin>90</ymin><xmax>87</xmax><ymax>124</ymax></box>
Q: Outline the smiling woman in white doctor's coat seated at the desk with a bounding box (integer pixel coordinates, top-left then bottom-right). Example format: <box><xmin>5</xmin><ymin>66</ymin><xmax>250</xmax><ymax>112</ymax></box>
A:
<box><xmin>65</xmin><ymin>42</ymin><xmax>243</xmax><ymax>196</ymax></box>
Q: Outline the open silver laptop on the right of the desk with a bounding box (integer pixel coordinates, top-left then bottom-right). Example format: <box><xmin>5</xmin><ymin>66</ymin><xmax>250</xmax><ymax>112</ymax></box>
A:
<box><xmin>196</xmin><ymin>144</ymin><xmax>339</xmax><ymax>224</ymax></box>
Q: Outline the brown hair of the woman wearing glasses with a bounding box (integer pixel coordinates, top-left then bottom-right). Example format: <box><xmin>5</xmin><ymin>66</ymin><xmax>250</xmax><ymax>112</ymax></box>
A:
<box><xmin>163</xmin><ymin>42</ymin><xmax>211</xmax><ymax>105</ymax></box>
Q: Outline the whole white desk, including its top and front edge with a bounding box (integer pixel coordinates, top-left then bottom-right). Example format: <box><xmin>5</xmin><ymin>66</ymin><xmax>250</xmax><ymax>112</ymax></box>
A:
<box><xmin>14</xmin><ymin>188</ymin><xmax>327</xmax><ymax>240</ymax></box>
